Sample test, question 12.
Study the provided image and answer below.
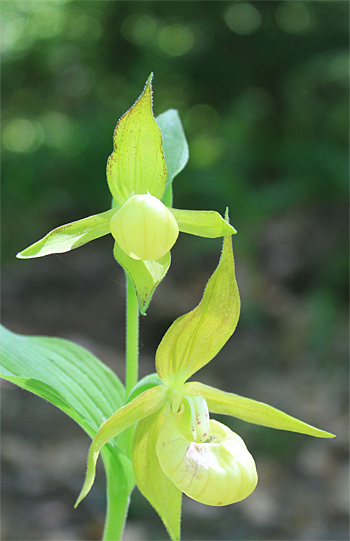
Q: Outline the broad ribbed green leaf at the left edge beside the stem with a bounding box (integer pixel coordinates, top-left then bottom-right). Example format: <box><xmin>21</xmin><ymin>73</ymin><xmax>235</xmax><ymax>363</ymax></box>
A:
<box><xmin>0</xmin><ymin>327</ymin><xmax>125</xmax><ymax>437</ymax></box>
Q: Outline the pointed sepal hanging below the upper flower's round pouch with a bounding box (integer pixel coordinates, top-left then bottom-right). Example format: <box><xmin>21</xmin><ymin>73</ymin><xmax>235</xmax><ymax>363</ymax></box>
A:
<box><xmin>114</xmin><ymin>242</ymin><xmax>171</xmax><ymax>315</ymax></box>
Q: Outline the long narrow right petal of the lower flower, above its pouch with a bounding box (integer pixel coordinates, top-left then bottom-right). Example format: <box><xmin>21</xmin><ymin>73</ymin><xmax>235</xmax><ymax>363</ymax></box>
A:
<box><xmin>185</xmin><ymin>382</ymin><xmax>335</xmax><ymax>438</ymax></box>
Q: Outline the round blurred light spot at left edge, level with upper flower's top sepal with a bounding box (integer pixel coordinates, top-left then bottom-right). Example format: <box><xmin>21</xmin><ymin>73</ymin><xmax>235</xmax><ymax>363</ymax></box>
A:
<box><xmin>2</xmin><ymin>118</ymin><xmax>44</xmax><ymax>152</ymax></box>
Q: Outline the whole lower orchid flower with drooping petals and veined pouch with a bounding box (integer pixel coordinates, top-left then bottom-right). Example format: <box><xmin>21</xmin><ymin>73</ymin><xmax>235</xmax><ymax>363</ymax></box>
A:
<box><xmin>76</xmin><ymin>235</ymin><xmax>333</xmax><ymax>540</ymax></box>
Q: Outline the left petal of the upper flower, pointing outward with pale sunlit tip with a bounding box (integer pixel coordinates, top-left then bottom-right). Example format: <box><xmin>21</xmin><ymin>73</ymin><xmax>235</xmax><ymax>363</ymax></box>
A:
<box><xmin>17</xmin><ymin>209</ymin><xmax>116</xmax><ymax>259</ymax></box>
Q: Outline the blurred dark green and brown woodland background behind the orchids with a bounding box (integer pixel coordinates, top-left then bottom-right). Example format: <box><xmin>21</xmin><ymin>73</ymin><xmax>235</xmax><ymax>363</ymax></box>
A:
<box><xmin>2</xmin><ymin>0</ymin><xmax>349</xmax><ymax>541</ymax></box>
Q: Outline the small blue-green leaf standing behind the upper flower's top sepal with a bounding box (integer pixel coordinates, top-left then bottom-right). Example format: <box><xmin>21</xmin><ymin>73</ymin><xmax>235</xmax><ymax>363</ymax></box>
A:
<box><xmin>156</xmin><ymin>109</ymin><xmax>189</xmax><ymax>207</ymax></box>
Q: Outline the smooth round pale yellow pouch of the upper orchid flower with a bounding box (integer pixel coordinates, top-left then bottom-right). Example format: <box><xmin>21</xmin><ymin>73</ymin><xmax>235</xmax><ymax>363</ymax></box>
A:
<box><xmin>110</xmin><ymin>194</ymin><xmax>179</xmax><ymax>261</ymax></box>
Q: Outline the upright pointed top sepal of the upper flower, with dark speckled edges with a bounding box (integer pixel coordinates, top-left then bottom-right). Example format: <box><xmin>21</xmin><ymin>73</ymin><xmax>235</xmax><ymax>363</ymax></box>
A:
<box><xmin>107</xmin><ymin>74</ymin><xmax>167</xmax><ymax>205</ymax></box>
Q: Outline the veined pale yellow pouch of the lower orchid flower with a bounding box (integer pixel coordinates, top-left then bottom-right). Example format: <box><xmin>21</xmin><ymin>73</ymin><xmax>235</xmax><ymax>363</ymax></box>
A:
<box><xmin>157</xmin><ymin>415</ymin><xmax>258</xmax><ymax>505</ymax></box>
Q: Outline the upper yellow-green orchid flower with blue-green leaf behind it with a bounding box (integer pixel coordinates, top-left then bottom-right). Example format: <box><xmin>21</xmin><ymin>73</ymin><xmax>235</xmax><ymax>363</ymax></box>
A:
<box><xmin>17</xmin><ymin>74</ymin><xmax>236</xmax><ymax>313</ymax></box>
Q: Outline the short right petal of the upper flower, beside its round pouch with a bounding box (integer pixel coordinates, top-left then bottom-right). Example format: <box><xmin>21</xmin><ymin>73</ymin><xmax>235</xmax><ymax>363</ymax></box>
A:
<box><xmin>170</xmin><ymin>208</ymin><xmax>237</xmax><ymax>239</ymax></box>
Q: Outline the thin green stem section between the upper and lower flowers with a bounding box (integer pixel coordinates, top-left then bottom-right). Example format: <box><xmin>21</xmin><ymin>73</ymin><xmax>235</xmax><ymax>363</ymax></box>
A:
<box><xmin>125</xmin><ymin>275</ymin><xmax>139</xmax><ymax>395</ymax></box>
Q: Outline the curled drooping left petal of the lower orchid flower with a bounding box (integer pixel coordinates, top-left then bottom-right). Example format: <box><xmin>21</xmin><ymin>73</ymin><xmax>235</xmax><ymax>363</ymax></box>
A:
<box><xmin>75</xmin><ymin>385</ymin><xmax>167</xmax><ymax>507</ymax></box>
